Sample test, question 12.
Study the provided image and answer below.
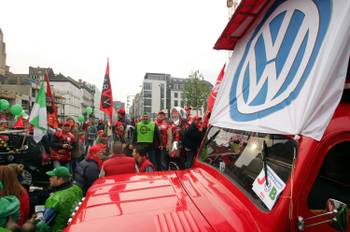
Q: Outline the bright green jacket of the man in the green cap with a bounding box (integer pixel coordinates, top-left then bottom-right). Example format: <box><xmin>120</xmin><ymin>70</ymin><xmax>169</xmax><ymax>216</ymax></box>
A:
<box><xmin>37</xmin><ymin>184</ymin><xmax>83</xmax><ymax>231</ymax></box>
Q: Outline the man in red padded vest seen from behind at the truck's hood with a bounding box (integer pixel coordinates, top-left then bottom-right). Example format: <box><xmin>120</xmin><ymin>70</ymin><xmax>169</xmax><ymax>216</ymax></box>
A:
<box><xmin>100</xmin><ymin>141</ymin><xmax>136</xmax><ymax>177</ymax></box>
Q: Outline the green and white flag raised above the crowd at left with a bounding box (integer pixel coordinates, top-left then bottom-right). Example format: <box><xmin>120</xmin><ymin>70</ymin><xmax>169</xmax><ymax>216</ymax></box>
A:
<box><xmin>29</xmin><ymin>84</ymin><xmax>47</xmax><ymax>143</ymax></box>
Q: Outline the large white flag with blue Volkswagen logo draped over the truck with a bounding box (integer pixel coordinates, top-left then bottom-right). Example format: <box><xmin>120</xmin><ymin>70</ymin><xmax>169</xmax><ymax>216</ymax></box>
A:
<box><xmin>210</xmin><ymin>0</ymin><xmax>350</xmax><ymax>140</ymax></box>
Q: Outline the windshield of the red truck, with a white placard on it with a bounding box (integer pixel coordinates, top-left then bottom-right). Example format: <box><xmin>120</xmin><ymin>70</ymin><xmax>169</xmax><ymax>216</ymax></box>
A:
<box><xmin>199</xmin><ymin>127</ymin><xmax>297</xmax><ymax>210</ymax></box>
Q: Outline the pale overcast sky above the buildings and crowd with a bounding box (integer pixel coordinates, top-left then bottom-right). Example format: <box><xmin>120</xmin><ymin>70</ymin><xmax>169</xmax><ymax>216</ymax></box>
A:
<box><xmin>0</xmin><ymin>0</ymin><xmax>228</xmax><ymax>101</ymax></box>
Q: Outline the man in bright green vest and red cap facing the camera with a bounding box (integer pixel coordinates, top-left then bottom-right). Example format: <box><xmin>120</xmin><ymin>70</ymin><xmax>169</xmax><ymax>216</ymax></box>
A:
<box><xmin>134</xmin><ymin>113</ymin><xmax>164</xmax><ymax>169</ymax></box>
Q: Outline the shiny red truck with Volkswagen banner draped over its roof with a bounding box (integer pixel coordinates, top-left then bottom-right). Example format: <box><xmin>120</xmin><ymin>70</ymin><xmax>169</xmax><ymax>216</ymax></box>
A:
<box><xmin>65</xmin><ymin>0</ymin><xmax>350</xmax><ymax>232</ymax></box>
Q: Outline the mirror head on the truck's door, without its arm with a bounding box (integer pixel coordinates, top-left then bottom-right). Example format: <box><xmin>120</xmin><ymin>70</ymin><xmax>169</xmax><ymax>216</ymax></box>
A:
<box><xmin>326</xmin><ymin>199</ymin><xmax>348</xmax><ymax>231</ymax></box>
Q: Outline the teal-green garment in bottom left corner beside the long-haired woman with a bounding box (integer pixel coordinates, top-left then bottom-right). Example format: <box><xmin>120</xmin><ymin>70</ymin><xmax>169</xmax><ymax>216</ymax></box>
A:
<box><xmin>0</xmin><ymin>196</ymin><xmax>19</xmax><ymax>227</ymax></box>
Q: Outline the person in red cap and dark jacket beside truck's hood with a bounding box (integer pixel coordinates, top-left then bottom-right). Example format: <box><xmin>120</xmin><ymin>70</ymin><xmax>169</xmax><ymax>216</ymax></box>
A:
<box><xmin>74</xmin><ymin>143</ymin><xmax>106</xmax><ymax>194</ymax></box>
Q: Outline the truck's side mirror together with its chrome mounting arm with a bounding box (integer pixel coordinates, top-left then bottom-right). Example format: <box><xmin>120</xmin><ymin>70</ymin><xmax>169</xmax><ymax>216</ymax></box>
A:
<box><xmin>298</xmin><ymin>199</ymin><xmax>348</xmax><ymax>232</ymax></box>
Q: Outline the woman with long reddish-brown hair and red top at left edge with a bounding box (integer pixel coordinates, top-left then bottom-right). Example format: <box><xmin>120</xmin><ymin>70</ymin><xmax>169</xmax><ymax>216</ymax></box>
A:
<box><xmin>0</xmin><ymin>166</ymin><xmax>30</xmax><ymax>225</ymax></box>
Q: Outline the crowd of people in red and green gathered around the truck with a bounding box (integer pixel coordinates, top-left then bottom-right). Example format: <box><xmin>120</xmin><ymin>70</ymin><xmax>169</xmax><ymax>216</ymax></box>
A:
<box><xmin>0</xmin><ymin>107</ymin><xmax>208</xmax><ymax>231</ymax></box>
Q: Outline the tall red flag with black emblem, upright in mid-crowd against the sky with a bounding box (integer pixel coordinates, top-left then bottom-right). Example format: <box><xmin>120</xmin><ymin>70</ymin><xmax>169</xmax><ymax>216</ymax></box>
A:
<box><xmin>100</xmin><ymin>60</ymin><xmax>113</xmax><ymax>125</ymax></box>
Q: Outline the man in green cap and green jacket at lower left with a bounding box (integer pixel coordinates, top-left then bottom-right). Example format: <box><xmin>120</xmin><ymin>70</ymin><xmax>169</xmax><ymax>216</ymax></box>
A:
<box><xmin>36</xmin><ymin>166</ymin><xmax>83</xmax><ymax>231</ymax></box>
